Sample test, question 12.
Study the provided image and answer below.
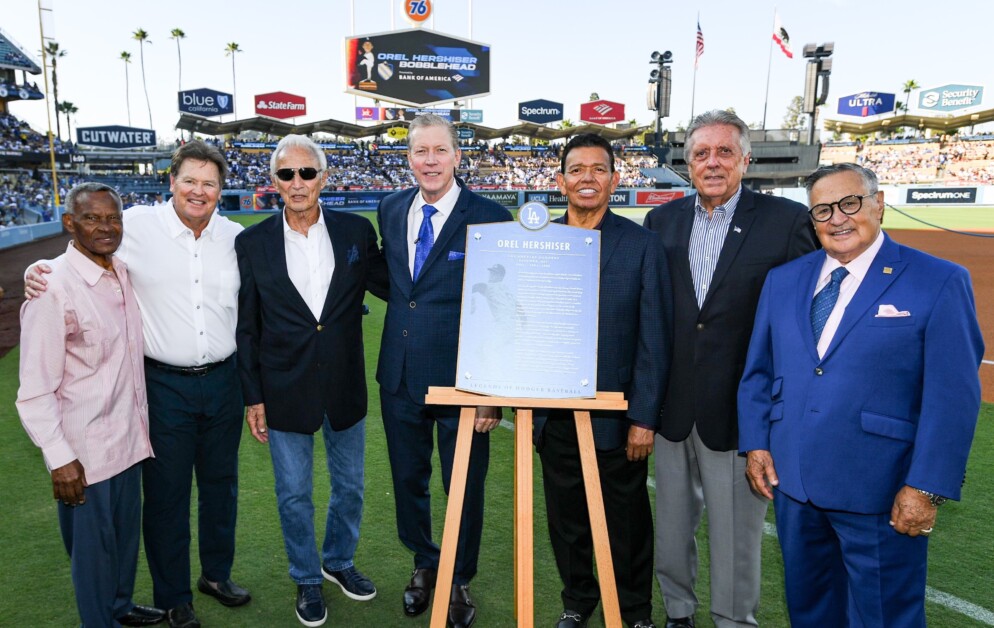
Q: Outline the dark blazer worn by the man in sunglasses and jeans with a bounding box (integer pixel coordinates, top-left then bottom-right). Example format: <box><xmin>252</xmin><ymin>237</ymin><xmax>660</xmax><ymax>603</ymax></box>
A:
<box><xmin>235</xmin><ymin>209</ymin><xmax>387</xmax><ymax>434</ymax></box>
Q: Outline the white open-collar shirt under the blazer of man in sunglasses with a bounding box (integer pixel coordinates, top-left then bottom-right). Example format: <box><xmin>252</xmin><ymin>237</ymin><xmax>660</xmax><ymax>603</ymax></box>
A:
<box><xmin>283</xmin><ymin>209</ymin><xmax>335</xmax><ymax>320</ymax></box>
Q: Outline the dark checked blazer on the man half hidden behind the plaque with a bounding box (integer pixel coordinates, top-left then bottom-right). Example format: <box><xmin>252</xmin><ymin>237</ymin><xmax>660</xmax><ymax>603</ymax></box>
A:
<box><xmin>535</xmin><ymin>209</ymin><xmax>673</xmax><ymax>450</ymax></box>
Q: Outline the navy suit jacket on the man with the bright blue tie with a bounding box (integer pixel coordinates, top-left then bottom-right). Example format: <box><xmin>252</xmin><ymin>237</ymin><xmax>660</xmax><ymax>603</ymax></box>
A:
<box><xmin>376</xmin><ymin>180</ymin><xmax>512</xmax><ymax>403</ymax></box>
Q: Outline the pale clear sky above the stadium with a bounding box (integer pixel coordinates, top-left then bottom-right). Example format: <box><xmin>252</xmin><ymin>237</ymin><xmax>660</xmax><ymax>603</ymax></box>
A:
<box><xmin>0</xmin><ymin>0</ymin><xmax>994</xmax><ymax>140</ymax></box>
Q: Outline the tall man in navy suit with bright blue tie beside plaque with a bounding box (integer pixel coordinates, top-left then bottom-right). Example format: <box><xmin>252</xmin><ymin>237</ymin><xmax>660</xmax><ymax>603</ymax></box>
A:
<box><xmin>376</xmin><ymin>114</ymin><xmax>511</xmax><ymax>628</ymax></box>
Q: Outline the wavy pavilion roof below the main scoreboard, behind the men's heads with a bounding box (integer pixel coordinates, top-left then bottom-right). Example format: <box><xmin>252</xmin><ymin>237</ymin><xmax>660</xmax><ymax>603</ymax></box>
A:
<box><xmin>176</xmin><ymin>113</ymin><xmax>649</xmax><ymax>141</ymax></box>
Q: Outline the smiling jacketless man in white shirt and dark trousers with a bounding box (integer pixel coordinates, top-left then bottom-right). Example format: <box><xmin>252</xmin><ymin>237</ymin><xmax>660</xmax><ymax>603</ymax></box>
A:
<box><xmin>25</xmin><ymin>140</ymin><xmax>252</xmax><ymax>628</ymax></box>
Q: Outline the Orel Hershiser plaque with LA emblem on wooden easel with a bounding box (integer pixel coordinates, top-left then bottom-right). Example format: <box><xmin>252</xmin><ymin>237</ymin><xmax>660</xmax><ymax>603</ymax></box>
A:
<box><xmin>455</xmin><ymin>203</ymin><xmax>600</xmax><ymax>399</ymax></box>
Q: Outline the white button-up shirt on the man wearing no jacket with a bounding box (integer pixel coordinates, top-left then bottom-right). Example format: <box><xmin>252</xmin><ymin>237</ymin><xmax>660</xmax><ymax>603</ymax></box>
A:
<box><xmin>117</xmin><ymin>202</ymin><xmax>242</xmax><ymax>366</ymax></box>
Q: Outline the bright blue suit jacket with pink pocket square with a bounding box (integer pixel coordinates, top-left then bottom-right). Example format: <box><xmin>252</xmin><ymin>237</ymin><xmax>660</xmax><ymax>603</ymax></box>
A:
<box><xmin>738</xmin><ymin>236</ymin><xmax>984</xmax><ymax>514</ymax></box>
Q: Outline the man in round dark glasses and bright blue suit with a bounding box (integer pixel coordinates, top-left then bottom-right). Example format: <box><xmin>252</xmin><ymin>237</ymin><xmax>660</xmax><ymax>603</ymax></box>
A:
<box><xmin>738</xmin><ymin>163</ymin><xmax>984</xmax><ymax>628</ymax></box>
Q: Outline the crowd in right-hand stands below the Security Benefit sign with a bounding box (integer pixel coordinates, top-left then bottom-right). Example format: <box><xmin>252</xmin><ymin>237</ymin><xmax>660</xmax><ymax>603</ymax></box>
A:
<box><xmin>822</xmin><ymin>136</ymin><xmax>994</xmax><ymax>185</ymax></box>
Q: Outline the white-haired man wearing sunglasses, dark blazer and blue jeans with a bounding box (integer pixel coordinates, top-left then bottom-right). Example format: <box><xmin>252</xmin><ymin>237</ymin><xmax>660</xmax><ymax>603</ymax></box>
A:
<box><xmin>235</xmin><ymin>135</ymin><xmax>387</xmax><ymax>626</ymax></box>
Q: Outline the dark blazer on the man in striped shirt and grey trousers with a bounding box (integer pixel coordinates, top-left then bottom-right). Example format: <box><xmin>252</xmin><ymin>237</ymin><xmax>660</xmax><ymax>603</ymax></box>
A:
<box><xmin>645</xmin><ymin>187</ymin><xmax>817</xmax><ymax>451</ymax></box>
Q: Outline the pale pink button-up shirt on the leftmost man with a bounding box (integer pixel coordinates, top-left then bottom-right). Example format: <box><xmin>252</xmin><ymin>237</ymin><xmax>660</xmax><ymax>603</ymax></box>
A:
<box><xmin>17</xmin><ymin>243</ymin><xmax>152</xmax><ymax>484</ymax></box>
